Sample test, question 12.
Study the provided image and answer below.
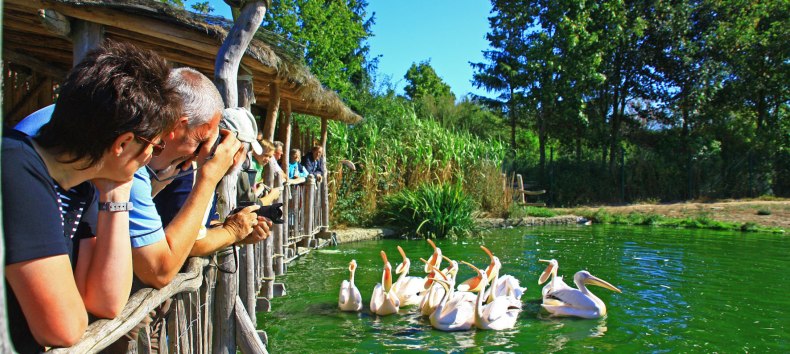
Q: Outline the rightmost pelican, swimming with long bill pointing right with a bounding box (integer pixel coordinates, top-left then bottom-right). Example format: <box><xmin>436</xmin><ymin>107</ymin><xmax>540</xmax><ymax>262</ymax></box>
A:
<box><xmin>541</xmin><ymin>270</ymin><xmax>622</xmax><ymax>318</ymax></box>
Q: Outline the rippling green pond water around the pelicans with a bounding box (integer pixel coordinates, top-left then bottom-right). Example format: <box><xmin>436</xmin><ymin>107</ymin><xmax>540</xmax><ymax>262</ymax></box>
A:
<box><xmin>258</xmin><ymin>226</ymin><xmax>790</xmax><ymax>353</ymax></box>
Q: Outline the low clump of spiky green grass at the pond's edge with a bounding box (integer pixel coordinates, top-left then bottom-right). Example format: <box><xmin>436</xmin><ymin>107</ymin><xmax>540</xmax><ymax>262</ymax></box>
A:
<box><xmin>382</xmin><ymin>183</ymin><xmax>475</xmax><ymax>238</ymax></box>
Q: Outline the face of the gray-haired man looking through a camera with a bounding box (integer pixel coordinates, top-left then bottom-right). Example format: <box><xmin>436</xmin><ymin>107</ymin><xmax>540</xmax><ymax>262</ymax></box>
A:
<box><xmin>148</xmin><ymin>112</ymin><xmax>222</xmax><ymax>170</ymax></box>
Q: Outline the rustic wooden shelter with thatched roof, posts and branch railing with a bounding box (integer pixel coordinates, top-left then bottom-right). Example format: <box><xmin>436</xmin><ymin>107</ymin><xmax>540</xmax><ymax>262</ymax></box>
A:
<box><xmin>2</xmin><ymin>0</ymin><xmax>361</xmax><ymax>353</ymax></box>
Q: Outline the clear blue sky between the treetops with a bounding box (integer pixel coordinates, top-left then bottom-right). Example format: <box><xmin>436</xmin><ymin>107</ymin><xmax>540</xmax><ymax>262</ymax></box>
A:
<box><xmin>204</xmin><ymin>0</ymin><xmax>491</xmax><ymax>98</ymax></box>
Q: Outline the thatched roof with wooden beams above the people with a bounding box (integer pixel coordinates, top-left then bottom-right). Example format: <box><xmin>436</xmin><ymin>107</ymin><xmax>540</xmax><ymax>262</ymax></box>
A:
<box><xmin>3</xmin><ymin>0</ymin><xmax>361</xmax><ymax>123</ymax></box>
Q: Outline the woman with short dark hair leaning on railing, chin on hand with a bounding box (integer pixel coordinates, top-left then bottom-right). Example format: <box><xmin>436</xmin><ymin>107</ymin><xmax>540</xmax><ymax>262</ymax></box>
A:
<box><xmin>0</xmin><ymin>42</ymin><xmax>181</xmax><ymax>353</ymax></box>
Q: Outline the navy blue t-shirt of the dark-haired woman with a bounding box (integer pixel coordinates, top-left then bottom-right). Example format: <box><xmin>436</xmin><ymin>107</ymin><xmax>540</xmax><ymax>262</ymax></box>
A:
<box><xmin>0</xmin><ymin>130</ymin><xmax>98</xmax><ymax>353</ymax></box>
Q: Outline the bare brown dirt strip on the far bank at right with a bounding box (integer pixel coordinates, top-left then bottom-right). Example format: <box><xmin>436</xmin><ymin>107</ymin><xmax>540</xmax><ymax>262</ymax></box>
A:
<box><xmin>560</xmin><ymin>200</ymin><xmax>790</xmax><ymax>230</ymax></box>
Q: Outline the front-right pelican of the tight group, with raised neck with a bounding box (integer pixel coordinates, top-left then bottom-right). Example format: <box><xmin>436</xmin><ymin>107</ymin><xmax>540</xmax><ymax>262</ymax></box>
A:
<box><xmin>463</xmin><ymin>262</ymin><xmax>521</xmax><ymax>330</ymax></box>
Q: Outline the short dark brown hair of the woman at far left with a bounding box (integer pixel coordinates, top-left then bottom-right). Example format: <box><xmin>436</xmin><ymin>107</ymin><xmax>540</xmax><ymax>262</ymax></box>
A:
<box><xmin>35</xmin><ymin>40</ymin><xmax>181</xmax><ymax>168</ymax></box>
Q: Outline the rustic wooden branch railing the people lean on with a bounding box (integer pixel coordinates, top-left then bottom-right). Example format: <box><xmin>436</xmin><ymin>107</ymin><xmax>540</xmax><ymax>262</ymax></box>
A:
<box><xmin>43</xmin><ymin>171</ymin><xmax>328</xmax><ymax>353</ymax></box>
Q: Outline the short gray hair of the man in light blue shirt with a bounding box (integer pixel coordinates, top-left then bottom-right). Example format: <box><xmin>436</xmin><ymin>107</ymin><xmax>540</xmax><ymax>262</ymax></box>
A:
<box><xmin>168</xmin><ymin>68</ymin><xmax>225</xmax><ymax>128</ymax></box>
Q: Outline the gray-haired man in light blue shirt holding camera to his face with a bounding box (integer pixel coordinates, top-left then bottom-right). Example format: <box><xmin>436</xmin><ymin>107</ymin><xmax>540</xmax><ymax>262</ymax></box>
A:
<box><xmin>129</xmin><ymin>68</ymin><xmax>269</xmax><ymax>288</ymax></box>
